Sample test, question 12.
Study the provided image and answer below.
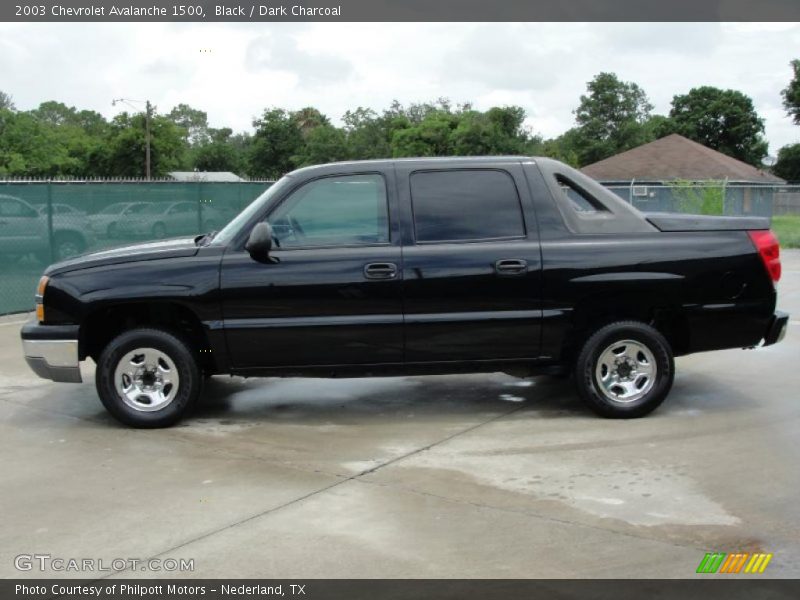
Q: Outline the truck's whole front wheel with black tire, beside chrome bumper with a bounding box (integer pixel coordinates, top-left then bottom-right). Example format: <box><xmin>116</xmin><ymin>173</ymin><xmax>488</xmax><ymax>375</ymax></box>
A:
<box><xmin>95</xmin><ymin>328</ymin><xmax>203</xmax><ymax>429</ymax></box>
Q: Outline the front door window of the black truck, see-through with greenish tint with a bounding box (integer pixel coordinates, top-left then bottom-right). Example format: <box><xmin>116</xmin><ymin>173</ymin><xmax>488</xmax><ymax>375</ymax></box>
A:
<box><xmin>268</xmin><ymin>175</ymin><xmax>389</xmax><ymax>248</ymax></box>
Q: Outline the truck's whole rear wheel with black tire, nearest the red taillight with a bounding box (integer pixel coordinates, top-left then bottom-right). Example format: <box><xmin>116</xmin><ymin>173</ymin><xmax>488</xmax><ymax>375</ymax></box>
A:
<box><xmin>575</xmin><ymin>321</ymin><xmax>675</xmax><ymax>419</ymax></box>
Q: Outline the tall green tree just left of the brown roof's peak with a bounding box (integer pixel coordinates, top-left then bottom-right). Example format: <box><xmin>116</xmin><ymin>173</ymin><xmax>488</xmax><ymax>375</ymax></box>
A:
<box><xmin>572</xmin><ymin>73</ymin><xmax>653</xmax><ymax>165</ymax></box>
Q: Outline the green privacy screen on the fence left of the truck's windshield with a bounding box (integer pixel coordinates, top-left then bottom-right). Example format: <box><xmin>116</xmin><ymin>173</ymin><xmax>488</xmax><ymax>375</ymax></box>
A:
<box><xmin>0</xmin><ymin>181</ymin><xmax>271</xmax><ymax>314</ymax></box>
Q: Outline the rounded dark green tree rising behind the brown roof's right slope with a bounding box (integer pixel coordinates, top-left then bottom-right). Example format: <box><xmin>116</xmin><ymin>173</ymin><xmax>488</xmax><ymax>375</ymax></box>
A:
<box><xmin>669</xmin><ymin>86</ymin><xmax>767</xmax><ymax>166</ymax></box>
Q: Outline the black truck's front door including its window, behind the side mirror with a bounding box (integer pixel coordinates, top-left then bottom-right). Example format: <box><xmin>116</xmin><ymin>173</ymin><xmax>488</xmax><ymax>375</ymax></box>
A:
<box><xmin>221</xmin><ymin>172</ymin><xmax>403</xmax><ymax>372</ymax></box>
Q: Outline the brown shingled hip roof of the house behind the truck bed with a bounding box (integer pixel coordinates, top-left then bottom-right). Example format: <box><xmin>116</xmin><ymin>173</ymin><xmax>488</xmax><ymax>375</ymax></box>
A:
<box><xmin>581</xmin><ymin>133</ymin><xmax>786</xmax><ymax>183</ymax></box>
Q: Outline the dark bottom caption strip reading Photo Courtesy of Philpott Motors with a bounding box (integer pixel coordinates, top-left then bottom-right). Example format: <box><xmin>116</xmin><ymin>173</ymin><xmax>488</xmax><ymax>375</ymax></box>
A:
<box><xmin>0</xmin><ymin>575</ymin><xmax>800</xmax><ymax>600</ymax></box>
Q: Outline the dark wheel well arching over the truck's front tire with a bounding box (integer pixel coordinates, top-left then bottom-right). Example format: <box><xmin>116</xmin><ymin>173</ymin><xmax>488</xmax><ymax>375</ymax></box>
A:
<box><xmin>80</xmin><ymin>302</ymin><xmax>216</xmax><ymax>372</ymax></box>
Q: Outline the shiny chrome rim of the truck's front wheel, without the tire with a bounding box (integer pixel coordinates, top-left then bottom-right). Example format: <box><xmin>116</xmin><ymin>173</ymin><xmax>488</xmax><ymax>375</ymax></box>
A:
<box><xmin>114</xmin><ymin>348</ymin><xmax>180</xmax><ymax>412</ymax></box>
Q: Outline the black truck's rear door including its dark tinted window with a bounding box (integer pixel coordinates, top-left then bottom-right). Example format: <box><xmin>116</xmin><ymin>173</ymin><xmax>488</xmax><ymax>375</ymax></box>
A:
<box><xmin>397</xmin><ymin>163</ymin><xmax>542</xmax><ymax>363</ymax></box>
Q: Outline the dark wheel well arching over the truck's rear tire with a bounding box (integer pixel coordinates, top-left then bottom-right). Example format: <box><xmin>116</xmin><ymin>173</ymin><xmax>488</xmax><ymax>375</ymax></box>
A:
<box><xmin>562</xmin><ymin>303</ymin><xmax>689</xmax><ymax>364</ymax></box>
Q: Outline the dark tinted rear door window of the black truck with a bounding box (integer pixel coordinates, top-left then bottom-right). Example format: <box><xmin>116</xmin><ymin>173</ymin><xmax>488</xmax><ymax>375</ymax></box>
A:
<box><xmin>411</xmin><ymin>170</ymin><xmax>525</xmax><ymax>243</ymax></box>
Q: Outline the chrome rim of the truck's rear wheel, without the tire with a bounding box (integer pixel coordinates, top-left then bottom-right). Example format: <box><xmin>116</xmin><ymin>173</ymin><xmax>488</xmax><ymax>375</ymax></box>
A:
<box><xmin>594</xmin><ymin>340</ymin><xmax>658</xmax><ymax>403</ymax></box>
